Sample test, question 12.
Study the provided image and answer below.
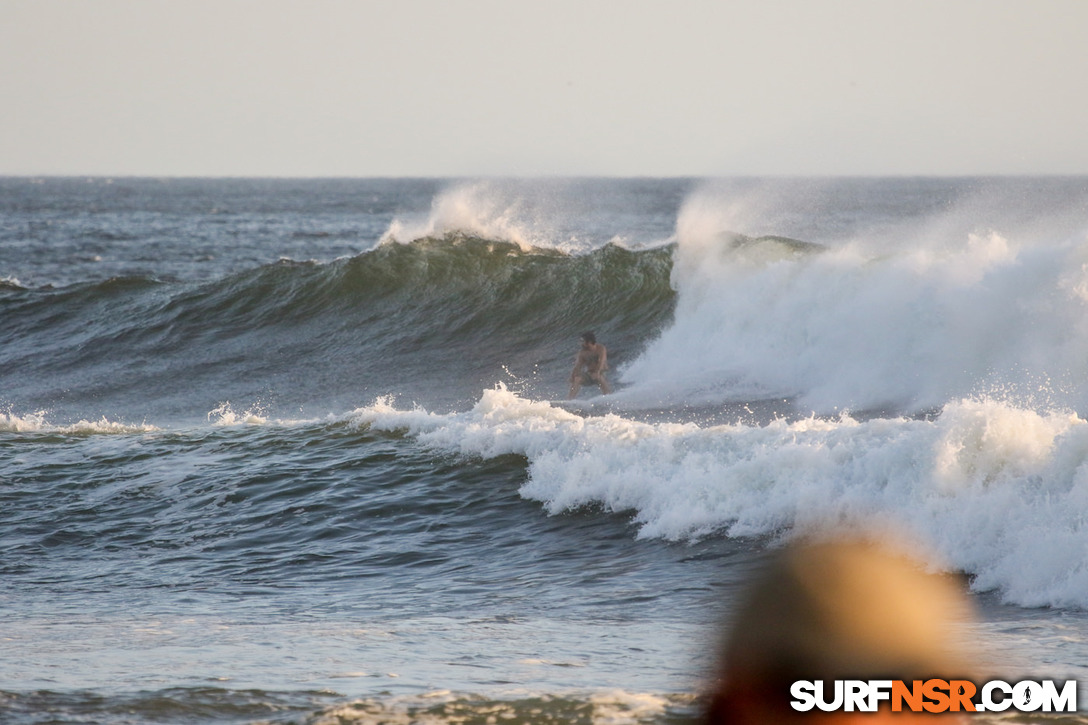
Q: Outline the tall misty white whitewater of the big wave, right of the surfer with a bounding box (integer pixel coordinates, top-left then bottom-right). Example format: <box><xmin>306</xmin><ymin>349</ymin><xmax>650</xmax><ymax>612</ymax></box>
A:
<box><xmin>619</xmin><ymin>183</ymin><xmax>1088</xmax><ymax>413</ymax></box>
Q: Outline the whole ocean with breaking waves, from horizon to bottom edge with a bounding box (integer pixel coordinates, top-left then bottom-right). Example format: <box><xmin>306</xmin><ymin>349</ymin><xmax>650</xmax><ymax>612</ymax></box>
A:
<box><xmin>6</xmin><ymin>177</ymin><xmax>1088</xmax><ymax>725</ymax></box>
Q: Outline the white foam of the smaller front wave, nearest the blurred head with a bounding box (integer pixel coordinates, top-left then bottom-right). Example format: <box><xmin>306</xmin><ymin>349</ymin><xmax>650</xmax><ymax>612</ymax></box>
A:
<box><xmin>351</xmin><ymin>386</ymin><xmax>1088</xmax><ymax>607</ymax></box>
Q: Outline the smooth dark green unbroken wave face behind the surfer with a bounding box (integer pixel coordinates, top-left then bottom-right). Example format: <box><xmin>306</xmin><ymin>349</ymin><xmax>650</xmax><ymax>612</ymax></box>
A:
<box><xmin>0</xmin><ymin>234</ymin><xmax>675</xmax><ymax>418</ymax></box>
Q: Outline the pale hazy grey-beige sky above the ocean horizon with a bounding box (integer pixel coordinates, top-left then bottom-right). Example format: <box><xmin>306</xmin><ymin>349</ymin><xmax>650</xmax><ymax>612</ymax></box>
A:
<box><xmin>0</xmin><ymin>0</ymin><xmax>1088</xmax><ymax>176</ymax></box>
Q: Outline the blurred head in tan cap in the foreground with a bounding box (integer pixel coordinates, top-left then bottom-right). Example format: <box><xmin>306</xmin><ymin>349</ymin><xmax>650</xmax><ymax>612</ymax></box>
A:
<box><xmin>707</xmin><ymin>538</ymin><xmax>972</xmax><ymax>725</ymax></box>
